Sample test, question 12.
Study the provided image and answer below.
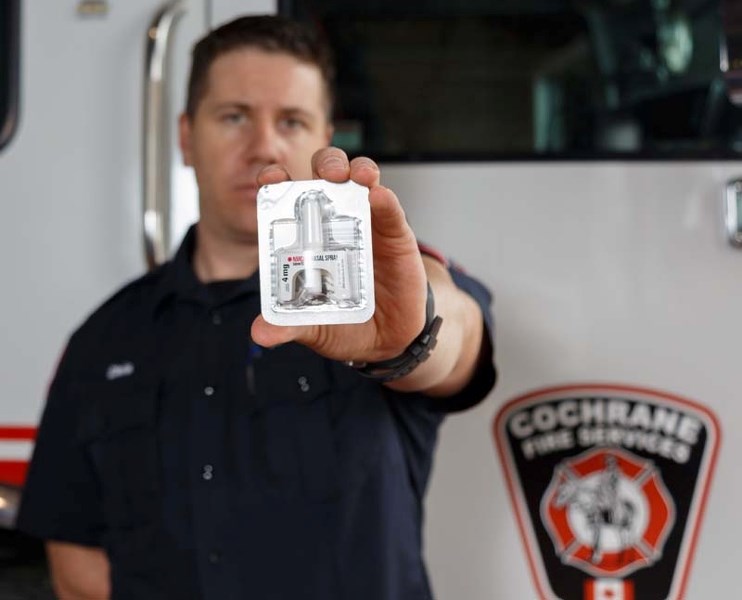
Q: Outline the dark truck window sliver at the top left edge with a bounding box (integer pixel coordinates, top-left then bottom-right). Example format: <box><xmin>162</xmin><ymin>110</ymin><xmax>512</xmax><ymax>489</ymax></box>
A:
<box><xmin>0</xmin><ymin>0</ymin><xmax>20</xmax><ymax>151</ymax></box>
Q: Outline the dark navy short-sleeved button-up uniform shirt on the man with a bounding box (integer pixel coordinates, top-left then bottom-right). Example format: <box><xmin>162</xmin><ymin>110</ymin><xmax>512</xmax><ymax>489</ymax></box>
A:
<box><xmin>18</xmin><ymin>229</ymin><xmax>495</xmax><ymax>600</ymax></box>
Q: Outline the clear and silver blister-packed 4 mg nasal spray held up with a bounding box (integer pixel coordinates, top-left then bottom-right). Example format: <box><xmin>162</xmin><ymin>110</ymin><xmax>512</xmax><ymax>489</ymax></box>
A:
<box><xmin>257</xmin><ymin>179</ymin><xmax>374</xmax><ymax>325</ymax></box>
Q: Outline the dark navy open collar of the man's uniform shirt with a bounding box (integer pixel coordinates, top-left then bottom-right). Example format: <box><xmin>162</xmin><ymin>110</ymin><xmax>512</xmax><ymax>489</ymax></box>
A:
<box><xmin>154</xmin><ymin>224</ymin><xmax>260</xmax><ymax>313</ymax></box>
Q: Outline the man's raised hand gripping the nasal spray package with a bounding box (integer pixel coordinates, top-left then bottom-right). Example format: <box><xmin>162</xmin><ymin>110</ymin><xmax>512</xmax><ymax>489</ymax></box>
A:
<box><xmin>251</xmin><ymin>148</ymin><xmax>427</xmax><ymax>361</ymax></box>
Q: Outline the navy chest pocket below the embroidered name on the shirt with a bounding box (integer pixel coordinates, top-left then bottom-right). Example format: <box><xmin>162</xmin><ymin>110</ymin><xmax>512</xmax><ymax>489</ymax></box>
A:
<box><xmin>77</xmin><ymin>382</ymin><xmax>159</xmax><ymax>528</ymax></box>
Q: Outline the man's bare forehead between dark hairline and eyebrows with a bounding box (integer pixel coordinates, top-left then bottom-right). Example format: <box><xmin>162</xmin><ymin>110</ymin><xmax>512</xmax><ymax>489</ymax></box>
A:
<box><xmin>203</xmin><ymin>48</ymin><xmax>327</xmax><ymax>113</ymax></box>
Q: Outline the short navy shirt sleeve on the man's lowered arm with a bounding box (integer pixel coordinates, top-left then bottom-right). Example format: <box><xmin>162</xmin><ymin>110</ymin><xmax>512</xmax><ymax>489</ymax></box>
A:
<box><xmin>16</xmin><ymin>338</ymin><xmax>103</xmax><ymax>546</ymax></box>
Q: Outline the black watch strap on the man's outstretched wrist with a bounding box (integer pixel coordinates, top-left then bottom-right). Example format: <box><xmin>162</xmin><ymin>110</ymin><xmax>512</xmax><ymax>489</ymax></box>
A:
<box><xmin>348</xmin><ymin>283</ymin><xmax>443</xmax><ymax>382</ymax></box>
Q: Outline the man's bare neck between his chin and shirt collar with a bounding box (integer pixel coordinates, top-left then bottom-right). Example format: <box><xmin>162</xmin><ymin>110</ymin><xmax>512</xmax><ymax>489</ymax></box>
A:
<box><xmin>193</xmin><ymin>223</ymin><xmax>258</xmax><ymax>283</ymax></box>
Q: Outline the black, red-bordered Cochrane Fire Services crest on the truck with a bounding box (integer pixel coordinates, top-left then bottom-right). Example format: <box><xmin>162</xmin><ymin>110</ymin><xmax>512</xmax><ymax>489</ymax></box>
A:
<box><xmin>494</xmin><ymin>384</ymin><xmax>719</xmax><ymax>600</ymax></box>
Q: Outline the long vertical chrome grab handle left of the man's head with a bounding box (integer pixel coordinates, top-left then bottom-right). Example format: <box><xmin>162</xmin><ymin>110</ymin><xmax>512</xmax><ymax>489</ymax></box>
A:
<box><xmin>142</xmin><ymin>0</ymin><xmax>186</xmax><ymax>269</ymax></box>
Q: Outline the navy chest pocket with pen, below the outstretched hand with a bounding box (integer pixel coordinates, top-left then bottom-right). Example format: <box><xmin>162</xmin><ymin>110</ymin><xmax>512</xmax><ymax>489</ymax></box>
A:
<box><xmin>246</xmin><ymin>344</ymin><xmax>339</xmax><ymax>501</ymax></box>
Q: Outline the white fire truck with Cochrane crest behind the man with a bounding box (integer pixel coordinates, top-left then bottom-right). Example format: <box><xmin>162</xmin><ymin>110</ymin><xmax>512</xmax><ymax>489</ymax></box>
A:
<box><xmin>0</xmin><ymin>0</ymin><xmax>742</xmax><ymax>600</ymax></box>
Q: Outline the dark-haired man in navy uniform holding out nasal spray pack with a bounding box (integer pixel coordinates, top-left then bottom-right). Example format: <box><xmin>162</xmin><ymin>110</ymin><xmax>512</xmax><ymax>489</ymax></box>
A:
<box><xmin>19</xmin><ymin>17</ymin><xmax>494</xmax><ymax>600</ymax></box>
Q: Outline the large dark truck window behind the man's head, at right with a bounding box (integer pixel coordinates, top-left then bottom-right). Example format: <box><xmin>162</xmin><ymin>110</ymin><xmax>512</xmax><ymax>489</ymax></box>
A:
<box><xmin>279</xmin><ymin>0</ymin><xmax>742</xmax><ymax>161</ymax></box>
